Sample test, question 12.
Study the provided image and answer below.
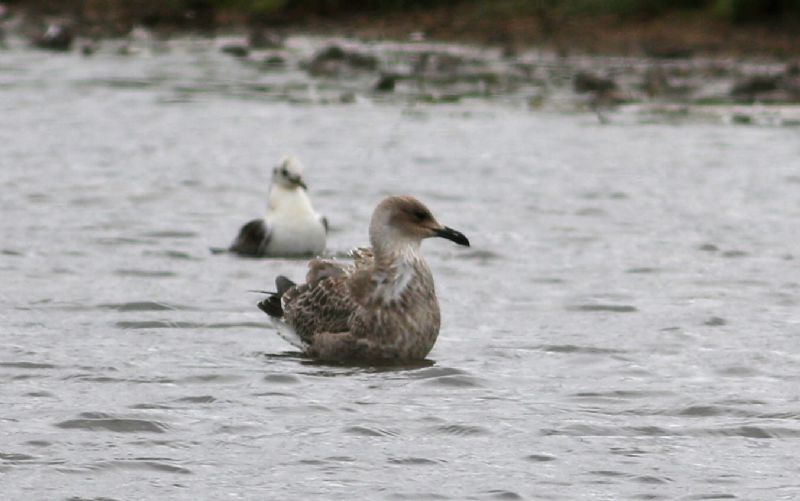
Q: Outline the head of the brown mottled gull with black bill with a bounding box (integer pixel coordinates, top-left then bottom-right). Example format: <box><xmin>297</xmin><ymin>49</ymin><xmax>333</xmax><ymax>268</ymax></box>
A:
<box><xmin>369</xmin><ymin>195</ymin><xmax>469</xmax><ymax>250</ymax></box>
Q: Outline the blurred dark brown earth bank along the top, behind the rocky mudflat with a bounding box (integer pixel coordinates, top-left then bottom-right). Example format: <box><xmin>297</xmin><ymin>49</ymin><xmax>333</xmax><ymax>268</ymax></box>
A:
<box><xmin>5</xmin><ymin>0</ymin><xmax>800</xmax><ymax>59</ymax></box>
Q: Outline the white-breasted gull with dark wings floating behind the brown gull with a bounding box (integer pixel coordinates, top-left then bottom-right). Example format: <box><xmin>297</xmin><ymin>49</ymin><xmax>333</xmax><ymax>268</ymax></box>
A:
<box><xmin>228</xmin><ymin>156</ymin><xmax>328</xmax><ymax>257</ymax></box>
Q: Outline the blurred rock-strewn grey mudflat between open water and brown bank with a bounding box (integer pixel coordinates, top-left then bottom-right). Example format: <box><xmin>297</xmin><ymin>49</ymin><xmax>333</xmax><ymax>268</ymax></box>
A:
<box><xmin>2</xmin><ymin>1</ymin><xmax>800</xmax><ymax>125</ymax></box>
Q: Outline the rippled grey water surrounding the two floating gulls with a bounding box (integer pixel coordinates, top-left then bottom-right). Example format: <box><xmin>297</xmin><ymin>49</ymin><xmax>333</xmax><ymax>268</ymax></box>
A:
<box><xmin>0</xmin><ymin>37</ymin><xmax>800</xmax><ymax>500</ymax></box>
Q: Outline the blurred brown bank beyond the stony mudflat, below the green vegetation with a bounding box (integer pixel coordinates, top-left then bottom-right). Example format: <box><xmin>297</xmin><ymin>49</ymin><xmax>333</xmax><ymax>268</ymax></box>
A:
<box><xmin>0</xmin><ymin>2</ymin><xmax>800</xmax><ymax>61</ymax></box>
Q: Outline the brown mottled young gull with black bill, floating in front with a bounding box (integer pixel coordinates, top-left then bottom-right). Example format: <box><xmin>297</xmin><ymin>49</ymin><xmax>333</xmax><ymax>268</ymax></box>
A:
<box><xmin>258</xmin><ymin>196</ymin><xmax>469</xmax><ymax>362</ymax></box>
